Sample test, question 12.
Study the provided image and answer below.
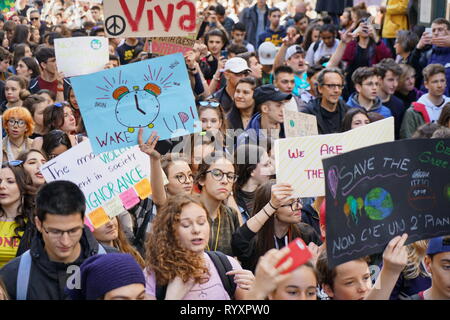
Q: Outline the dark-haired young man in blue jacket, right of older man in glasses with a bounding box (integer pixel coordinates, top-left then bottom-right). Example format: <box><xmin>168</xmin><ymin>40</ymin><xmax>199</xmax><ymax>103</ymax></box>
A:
<box><xmin>347</xmin><ymin>67</ymin><xmax>392</xmax><ymax>118</ymax></box>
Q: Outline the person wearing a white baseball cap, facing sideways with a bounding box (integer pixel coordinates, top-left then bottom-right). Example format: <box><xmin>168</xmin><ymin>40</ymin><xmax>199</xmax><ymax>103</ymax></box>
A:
<box><xmin>213</xmin><ymin>57</ymin><xmax>252</xmax><ymax>113</ymax></box>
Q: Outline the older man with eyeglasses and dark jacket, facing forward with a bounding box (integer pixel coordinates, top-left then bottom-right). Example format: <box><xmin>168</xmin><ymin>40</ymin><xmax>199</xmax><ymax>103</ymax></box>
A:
<box><xmin>300</xmin><ymin>68</ymin><xmax>349</xmax><ymax>134</ymax></box>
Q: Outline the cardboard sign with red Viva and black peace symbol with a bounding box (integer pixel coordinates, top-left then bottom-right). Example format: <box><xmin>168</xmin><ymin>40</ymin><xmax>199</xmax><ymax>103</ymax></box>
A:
<box><xmin>103</xmin><ymin>0</ymin><xmax>196</xmax><ymax>37</ymax></box>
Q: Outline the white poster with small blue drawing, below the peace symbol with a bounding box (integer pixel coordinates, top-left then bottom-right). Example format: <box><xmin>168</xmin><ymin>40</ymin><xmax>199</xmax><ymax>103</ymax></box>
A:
<box><xmin>55</xmin><ymin>37</ymin><xmax>109</xmax><ymax>77</ymax></box>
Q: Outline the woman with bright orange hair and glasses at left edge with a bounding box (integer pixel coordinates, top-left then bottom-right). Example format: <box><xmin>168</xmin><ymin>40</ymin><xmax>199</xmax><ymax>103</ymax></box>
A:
<box><xmin>3</xmin><ymin>107</ymin><xmax>34</xmax><ymax>161</ymax></box>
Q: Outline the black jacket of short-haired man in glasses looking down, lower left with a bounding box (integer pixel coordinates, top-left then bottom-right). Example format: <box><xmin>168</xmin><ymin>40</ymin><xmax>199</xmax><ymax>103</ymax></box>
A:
<box><xmin>0</xmin><ymin>227</ymin><xmax>117</xmax><ymax>300</ymax></box>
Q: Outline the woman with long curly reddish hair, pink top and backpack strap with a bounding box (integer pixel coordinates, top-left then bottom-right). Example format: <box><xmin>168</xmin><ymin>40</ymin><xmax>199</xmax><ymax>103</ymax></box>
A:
<box><xmin>144</xmin><ymin>195</ymin><xmax>254</xmax><ymax>300</ymax></box>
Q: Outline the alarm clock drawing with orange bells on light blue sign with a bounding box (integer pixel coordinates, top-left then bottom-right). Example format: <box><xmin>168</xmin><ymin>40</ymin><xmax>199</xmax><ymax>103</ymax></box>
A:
<box><xmin>113</xmin><ymin>83</ymin><xmax>161</xmax><ymax>133</ymax></box>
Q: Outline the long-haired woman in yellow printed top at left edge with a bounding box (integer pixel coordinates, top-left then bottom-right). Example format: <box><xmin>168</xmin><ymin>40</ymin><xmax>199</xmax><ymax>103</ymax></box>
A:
<box><xmin>0</xmin><ymin>162</ymin><xmax>33</xmax><ymax>269</ymax></box>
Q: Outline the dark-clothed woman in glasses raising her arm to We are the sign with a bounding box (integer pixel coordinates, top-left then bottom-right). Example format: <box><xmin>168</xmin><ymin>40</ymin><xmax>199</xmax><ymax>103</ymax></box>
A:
<box><xmin>232</xmin><ymin>180</ymin><xmax>322</xmax><ymax>271</ymax></box>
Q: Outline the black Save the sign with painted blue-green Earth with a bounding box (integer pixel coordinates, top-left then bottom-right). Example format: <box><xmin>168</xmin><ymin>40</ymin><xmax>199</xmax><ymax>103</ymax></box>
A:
<box><xmin>323</xmin><ymin>139</ymin><xmax>450</xmax><ymax>266</ymax></box>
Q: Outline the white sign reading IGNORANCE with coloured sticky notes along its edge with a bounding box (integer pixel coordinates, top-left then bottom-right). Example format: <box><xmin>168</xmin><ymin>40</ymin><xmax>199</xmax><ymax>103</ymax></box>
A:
<box><xmin>41</xmin><ymin>141</ymin><xmax>150</xmax><ymax>228</ymax></box>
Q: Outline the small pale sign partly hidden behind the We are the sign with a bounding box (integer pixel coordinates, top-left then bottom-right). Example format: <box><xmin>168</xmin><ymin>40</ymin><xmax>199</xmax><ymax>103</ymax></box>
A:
<box><xmin>284</xmin><ymin>109</ymin><xmax>319</xmax><ymax>138</ymax></box>
